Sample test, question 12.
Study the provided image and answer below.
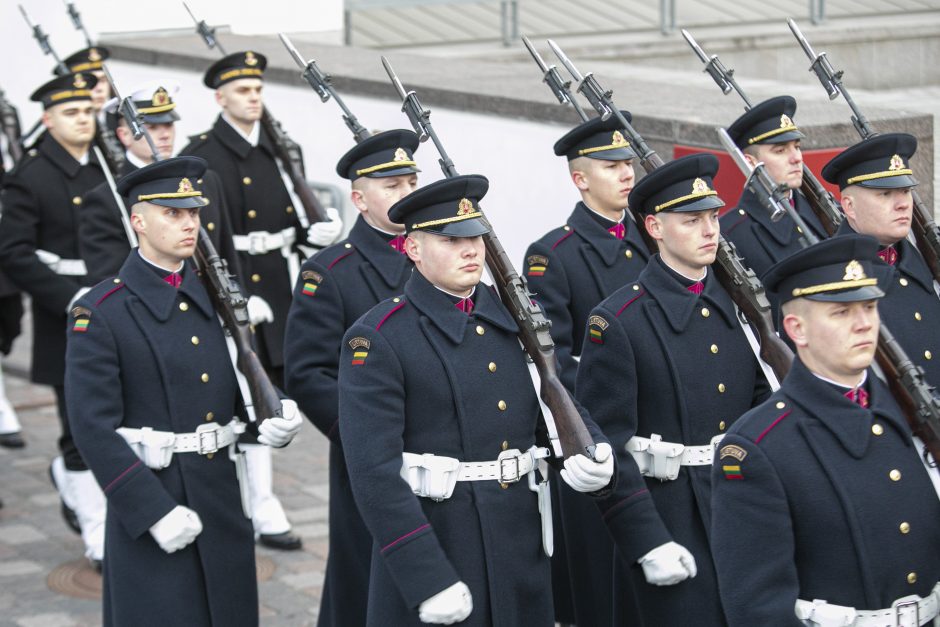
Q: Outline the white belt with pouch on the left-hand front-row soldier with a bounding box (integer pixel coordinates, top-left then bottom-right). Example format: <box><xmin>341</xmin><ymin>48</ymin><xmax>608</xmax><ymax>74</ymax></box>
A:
<box><xmin>117</xmin><ymin>418</ymin><xmax>245</xmax><ymax>470</ymax></box>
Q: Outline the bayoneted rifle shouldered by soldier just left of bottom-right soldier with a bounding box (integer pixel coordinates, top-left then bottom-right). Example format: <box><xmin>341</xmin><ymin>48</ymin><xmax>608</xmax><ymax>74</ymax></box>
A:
<box><xmin>548</xmin><ymin>39</ymin><xmax>793</xmax><ymax>381</ymax></box>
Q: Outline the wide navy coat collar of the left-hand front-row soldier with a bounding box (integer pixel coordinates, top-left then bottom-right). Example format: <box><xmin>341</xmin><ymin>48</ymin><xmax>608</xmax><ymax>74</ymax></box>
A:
<box><xmin>118</xmin><ymin>248</ymin><xmax>215</xmax><ymax>322</ymax></box>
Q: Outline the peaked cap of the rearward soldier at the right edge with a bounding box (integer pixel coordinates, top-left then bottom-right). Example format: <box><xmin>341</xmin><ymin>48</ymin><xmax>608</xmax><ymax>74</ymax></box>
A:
<box><xmin>822</xmin><ymin>133</ymin><xmax>917</xmax><ymax>189</ymax></box>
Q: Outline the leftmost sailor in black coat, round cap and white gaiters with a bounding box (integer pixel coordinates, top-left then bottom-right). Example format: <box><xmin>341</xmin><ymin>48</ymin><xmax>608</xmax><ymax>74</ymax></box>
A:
<box><xmin>0</xmin><ymin>72</ymin><xmax>104</xmax><ymax>564</ymax></box>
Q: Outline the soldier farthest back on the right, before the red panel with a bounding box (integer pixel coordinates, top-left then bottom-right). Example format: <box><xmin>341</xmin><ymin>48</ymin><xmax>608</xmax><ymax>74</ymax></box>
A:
<box><xmin>721</xmin><ymin>96</ymin><xmax>828</xmax><ymax>284</ymax></box>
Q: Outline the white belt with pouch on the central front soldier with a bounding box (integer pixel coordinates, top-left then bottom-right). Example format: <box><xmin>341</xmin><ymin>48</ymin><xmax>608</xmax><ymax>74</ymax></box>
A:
<box><xmin>401</xmin><ymin>446</ymin><xmax>551</xmax><ymax>501</ymax></box>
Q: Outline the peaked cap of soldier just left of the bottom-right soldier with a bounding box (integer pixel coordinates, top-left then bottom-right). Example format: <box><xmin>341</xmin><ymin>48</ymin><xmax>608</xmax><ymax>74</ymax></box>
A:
<box><xmin>628</xmin><ymin>154</ymin><xmax>725</xmax><ymax>215</ymax></box>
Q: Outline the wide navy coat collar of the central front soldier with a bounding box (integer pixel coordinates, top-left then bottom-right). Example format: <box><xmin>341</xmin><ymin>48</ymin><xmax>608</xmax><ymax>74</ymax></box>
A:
<box><xmin>405</xmin><ymin>271</ymin><xmax>519</xmax><ymax>344</ymax></box>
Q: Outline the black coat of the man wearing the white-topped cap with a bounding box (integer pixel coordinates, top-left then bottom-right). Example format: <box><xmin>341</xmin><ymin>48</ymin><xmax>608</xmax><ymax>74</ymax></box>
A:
<box><xmin>78</xmin><ymin>160</ymin><xmax>239</xmax><ymax>283</ymax></box>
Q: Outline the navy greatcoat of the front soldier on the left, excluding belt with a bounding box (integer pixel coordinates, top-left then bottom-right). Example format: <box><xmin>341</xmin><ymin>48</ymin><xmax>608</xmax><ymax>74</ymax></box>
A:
<box><xmin>66</xmin><ymin>251</ymin><xmax>258</xmax><ymax>627</ymax></box>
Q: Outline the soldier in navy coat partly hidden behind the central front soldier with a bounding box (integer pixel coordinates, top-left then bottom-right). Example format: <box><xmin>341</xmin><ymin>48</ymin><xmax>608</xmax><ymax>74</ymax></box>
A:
<box><xmin>284</xmin><ymin>130</ymin><xmax>419</xmax><ymax>626</ymax></box>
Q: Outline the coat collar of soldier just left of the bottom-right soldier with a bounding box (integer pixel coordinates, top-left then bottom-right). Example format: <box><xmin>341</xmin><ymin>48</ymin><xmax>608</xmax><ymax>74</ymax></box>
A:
<box><xmin>639</xmin><ymin>253</ymin><xmax>737</xmax><ymax>333</ymax></box>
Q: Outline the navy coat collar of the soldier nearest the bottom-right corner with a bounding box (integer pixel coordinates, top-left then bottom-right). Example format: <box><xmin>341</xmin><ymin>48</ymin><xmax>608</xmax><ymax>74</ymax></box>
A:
<box><xmin>783</xmin><ymin>358</ymin><xmax>911</xmax><ymax>459</ymax></box>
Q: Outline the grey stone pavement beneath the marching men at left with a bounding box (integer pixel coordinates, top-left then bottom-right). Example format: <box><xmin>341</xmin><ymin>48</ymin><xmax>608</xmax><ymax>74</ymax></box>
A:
<box><xmin>0</xmin><ymin>316</ymin><xmax>329</xmax><ymax>627</ymax></box>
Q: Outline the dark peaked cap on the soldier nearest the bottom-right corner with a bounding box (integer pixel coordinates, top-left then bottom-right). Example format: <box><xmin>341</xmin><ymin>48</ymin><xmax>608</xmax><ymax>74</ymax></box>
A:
<box><xmin>761</xmin><ymin>235</ymin><xmax>884</xmax><ymax>304</ymax></box>
